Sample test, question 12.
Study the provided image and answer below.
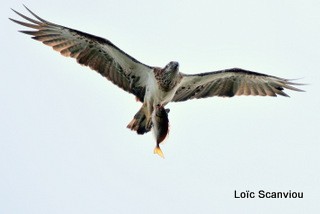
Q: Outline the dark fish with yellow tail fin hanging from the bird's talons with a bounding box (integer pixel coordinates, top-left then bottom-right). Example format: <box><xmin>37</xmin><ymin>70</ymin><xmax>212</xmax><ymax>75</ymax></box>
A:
<box><xmin>152</xmin><ymin>105</ymin><xmax>170</xmax><ymax>158</ymax></box>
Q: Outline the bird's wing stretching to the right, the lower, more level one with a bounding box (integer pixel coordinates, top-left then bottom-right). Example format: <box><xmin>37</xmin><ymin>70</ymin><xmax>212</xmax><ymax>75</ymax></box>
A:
<box><xmin>172</xmin><ymin>68</ymin><xmax>304</xmax><ymax>102</ymax></box>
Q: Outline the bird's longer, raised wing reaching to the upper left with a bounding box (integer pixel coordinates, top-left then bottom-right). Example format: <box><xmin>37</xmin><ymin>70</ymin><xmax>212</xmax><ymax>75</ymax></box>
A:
<box><xmin>10</xmin><ymin>7</ymin><xmax>153</xmax><ymax>101</ymax></box>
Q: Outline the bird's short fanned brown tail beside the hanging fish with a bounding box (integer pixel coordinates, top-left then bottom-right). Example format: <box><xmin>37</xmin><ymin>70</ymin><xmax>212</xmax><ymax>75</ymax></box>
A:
<box><xmin>127</xmin><ymin>106</ymin><xmax>151</xmax><ymax>134</ymax></box>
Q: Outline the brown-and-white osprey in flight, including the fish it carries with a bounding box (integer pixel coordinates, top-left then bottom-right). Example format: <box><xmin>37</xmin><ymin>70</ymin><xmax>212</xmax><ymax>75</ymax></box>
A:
<box><xmin>10</xmin><ymin>7</ymin><xmax>303</xmax><ymax>157</ymax></box>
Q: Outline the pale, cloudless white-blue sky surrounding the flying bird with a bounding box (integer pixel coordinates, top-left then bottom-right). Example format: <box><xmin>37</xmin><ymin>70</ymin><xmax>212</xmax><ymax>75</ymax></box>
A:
<box><xmin>0</xmin><ymin>0</ymin><xmax>320</xmax><ymax>214</ymax></box>
